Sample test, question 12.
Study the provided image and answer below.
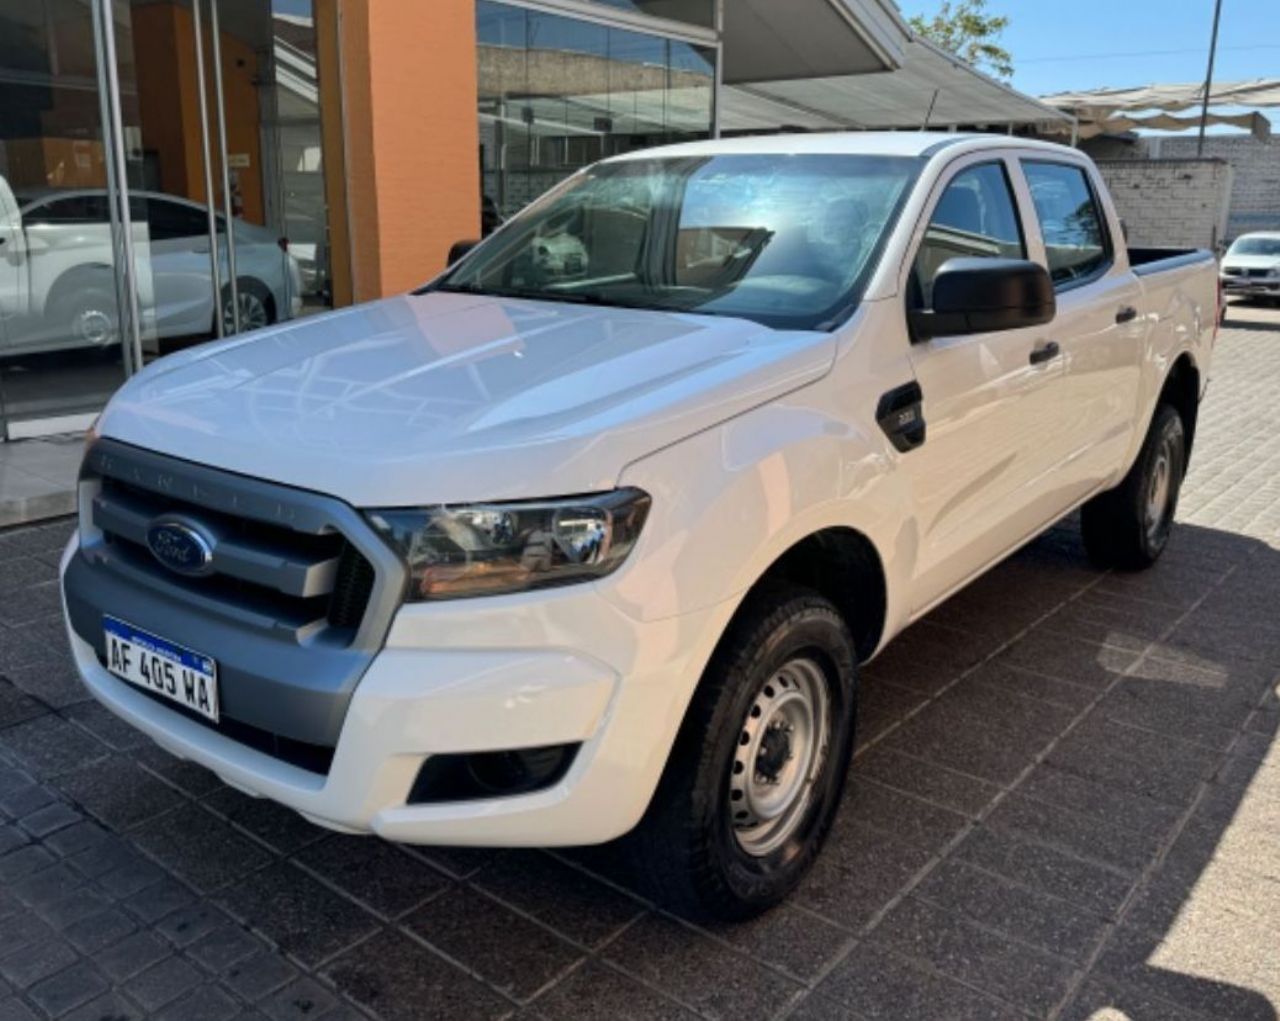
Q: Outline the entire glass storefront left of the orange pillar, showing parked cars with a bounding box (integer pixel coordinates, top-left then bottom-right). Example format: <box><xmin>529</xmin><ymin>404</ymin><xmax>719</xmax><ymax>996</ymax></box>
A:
<box><xmin>0</xmin><ymin>0</ymin><xmax>332</xmax><ymax>432</ymax></box>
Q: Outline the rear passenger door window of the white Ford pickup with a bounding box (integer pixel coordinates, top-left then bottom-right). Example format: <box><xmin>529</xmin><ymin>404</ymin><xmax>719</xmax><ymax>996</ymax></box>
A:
<box><xmin>1023</xmin><ymin>160</ymin><xmax>1111</xmax><ymax>284</ymax></box>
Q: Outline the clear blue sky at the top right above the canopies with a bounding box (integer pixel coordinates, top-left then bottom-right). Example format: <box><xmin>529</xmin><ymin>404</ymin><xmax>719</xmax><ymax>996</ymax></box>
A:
<box><xmin>899</xmin><ymin>0</ymin><xmax>1280</xmax><ymax>95</ymax></box>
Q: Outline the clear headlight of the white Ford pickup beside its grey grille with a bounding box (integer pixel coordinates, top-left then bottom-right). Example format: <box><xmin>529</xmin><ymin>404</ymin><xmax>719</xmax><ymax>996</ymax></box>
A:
<box><xmin>367</xmin><ymin>489</ymin><xmax>649</xmax><ymax>603</ymax></box>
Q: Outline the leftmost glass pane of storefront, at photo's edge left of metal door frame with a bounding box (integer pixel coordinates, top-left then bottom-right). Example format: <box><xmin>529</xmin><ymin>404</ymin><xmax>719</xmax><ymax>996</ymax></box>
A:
<box><xmin>0</xmin><ymin>0</ymin><xmax>124</xmax><ymax>425</ymax></box>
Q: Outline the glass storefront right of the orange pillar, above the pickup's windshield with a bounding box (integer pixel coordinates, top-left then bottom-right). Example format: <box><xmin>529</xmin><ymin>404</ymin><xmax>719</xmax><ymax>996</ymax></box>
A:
<box><xmin>476</xmin><ymin>0</ymin><xmax>716</xmax><ymax>216</ymax></box>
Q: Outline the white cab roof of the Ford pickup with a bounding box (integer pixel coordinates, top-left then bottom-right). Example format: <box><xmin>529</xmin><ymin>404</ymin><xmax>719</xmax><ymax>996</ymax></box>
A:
<box><xmin>605</xmin><ymin>132</ymin><xmax>1080</xmax><ymax>162</ymax></box>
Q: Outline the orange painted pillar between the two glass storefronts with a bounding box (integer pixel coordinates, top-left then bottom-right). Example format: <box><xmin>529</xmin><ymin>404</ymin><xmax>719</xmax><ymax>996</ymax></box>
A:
<box><xmin>340</xmin><ymin>0</ymin><xmax>480</xmax><ymax>301</ymax></box>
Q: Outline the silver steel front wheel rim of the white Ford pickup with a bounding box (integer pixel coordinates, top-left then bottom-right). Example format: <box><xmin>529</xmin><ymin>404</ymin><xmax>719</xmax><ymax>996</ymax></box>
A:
<box><xmin>728</xmin><ymin>658</ymin><xmax>829</xmax><ymax>857</ymax></box>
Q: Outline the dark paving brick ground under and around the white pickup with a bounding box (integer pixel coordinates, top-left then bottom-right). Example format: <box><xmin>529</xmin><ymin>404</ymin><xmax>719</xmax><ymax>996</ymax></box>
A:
<box><xmin>0</xmin><ymin>299</ymin><xmax>1280</xmax><ymax>1021</ymax></box>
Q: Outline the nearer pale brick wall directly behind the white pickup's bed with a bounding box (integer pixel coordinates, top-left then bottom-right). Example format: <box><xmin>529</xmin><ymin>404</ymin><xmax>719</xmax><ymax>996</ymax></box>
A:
<box><xmin>1098</xmin><ymin>159</ymin><xmax>1233</xmax><ymax>249</ymax></box>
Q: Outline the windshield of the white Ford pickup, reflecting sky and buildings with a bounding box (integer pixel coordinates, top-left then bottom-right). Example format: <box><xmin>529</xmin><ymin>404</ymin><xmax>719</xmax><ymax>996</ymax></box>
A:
<box><xmin>435</xmin><ymin>155</ymin><xmax>922</xmax><ymax>329</ymax></box>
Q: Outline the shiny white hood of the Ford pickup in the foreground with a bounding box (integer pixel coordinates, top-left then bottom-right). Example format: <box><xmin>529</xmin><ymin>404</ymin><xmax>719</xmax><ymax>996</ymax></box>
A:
<box><xmin>99</xmin><ymin>292</ymin><xmax>836</xmax><ymax>507</ymax></box>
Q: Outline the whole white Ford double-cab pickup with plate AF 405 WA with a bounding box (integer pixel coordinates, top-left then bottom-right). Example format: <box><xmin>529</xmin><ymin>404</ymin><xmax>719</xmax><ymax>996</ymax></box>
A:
<box><xmin>63</xmin><ymin>133</ymin><xmax>1217</xmax><ymax>917</ymax></box>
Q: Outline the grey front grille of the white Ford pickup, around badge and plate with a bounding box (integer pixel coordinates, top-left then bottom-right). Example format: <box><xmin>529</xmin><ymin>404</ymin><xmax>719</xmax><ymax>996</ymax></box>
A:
<box><xmin>64</xmin><ymin>439</ymin><xmax>404</xmax><ymax>773</ymax></box>
